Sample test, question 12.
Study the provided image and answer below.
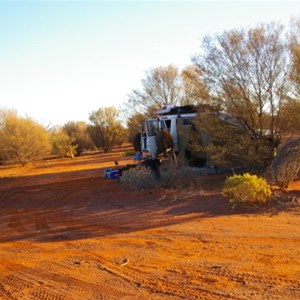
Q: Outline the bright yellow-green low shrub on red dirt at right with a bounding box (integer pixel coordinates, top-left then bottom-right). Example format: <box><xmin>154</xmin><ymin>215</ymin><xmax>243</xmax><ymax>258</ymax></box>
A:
<box><xmin>223</xmin><ymin>173</ymin><xmax>272</xmax><ymax>204</ymax></box>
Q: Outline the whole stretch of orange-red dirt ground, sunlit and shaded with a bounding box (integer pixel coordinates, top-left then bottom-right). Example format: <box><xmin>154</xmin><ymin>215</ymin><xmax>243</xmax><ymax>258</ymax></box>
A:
<box><xmin>0</xmin><ymin>152</ymin><xmax>300</xmax><ymax>300</ymax></box>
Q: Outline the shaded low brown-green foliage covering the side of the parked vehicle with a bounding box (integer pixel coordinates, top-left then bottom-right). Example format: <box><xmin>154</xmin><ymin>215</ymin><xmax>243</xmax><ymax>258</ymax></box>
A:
<box><xmin>188</xmin><ymin>112</ymin><xmax>277</xmax><ymax>167</ymax></box>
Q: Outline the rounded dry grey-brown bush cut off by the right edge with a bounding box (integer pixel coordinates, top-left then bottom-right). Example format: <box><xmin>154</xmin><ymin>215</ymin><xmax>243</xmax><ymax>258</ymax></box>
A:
<box><xmin>270</xmin><ymin>138</ymin><xmax>300</xmax><ymax>187</ymax></box>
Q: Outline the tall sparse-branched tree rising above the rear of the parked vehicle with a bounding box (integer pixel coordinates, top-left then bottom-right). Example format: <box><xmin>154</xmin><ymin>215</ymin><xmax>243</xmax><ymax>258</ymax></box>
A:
<box><xmin>193</xmin><ymin>23</ymin><xmax>289</xmax><ymax>135</ymax></box>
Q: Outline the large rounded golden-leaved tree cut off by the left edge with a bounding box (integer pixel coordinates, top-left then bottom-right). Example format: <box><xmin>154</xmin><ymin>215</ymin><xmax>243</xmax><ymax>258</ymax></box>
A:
<box><xmin>0</xmin><ymin>112</ymin><xmax>51</xmax><ymax>165</ymax></box>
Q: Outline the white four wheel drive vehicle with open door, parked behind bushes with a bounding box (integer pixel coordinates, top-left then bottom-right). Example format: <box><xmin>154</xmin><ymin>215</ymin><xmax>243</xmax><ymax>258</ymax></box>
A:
<box><xmin>139</xmin><ymin>105</ymin><xmax>279</xmax><ymax>168</ymax></box>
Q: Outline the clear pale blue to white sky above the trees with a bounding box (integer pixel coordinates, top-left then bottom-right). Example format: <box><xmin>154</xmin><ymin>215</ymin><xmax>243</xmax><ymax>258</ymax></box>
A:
<box><xmin>0</xmin><ymin>0</ymin><xmax>300</xmax><ymax>125</ymax></box>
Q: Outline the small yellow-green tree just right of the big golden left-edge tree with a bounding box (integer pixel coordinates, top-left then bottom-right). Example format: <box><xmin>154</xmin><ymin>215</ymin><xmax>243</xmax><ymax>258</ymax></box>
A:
<box><xmin>51</xmin><ymin>128</ymin><xmax>77</xmax><ymax>158</ymax></box>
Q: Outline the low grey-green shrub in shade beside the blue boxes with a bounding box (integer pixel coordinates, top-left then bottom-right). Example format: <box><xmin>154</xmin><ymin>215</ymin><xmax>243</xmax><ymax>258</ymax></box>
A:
<box><xmin>120</xmin><ymin>165</ymin><xmax>158</xmax><ymax>190</ymax></box>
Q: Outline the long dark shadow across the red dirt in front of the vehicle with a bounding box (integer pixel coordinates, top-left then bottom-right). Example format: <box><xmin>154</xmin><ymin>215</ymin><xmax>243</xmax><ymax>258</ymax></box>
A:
<box><xmin>0</xmin><ymin>170</ymin><xmax>298</xmax><ymax>242</ymax></box>
